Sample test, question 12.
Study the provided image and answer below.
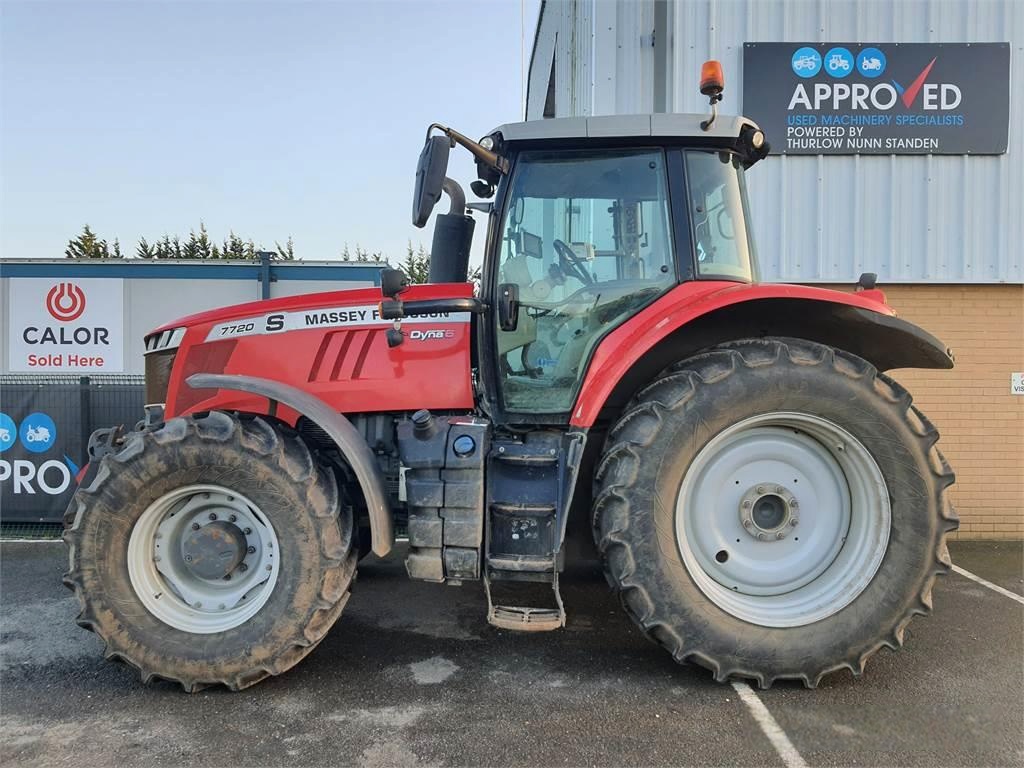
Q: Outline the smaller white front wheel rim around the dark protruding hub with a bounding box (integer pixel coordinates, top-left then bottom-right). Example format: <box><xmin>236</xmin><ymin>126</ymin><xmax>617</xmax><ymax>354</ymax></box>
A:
<box><xmin>128</xmin><ymin>484</ymin><xmax>281</xmax><ymax>635</ymax></box>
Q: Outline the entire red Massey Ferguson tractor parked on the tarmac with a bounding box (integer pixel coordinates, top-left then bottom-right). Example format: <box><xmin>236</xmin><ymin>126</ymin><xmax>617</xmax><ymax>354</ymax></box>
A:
<box><xmin>66</xmin><ymin>71</ymin><xmax>957</xmax><ymax>691</ymax></box>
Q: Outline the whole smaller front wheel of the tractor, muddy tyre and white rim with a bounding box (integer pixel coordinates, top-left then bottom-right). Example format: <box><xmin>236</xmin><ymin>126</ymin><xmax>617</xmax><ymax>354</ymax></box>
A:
<box><xmin>65</xmin><ymin>412</ymin><xmax>356</xmax><ymax>691</ymax></box>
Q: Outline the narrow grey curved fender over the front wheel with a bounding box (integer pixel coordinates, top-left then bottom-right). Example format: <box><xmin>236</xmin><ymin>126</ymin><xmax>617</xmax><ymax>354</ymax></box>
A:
<box><xmin>186</xmin><ymin>374</ymin><xmax>394</xmax><ymax>557</ymax></box>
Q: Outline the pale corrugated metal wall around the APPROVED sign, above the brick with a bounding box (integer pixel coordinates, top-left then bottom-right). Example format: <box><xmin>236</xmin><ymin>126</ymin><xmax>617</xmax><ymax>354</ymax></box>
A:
<box><xmin>527</xmin><ymin>0</ymin><xmax>1024</xmax><ymax>283</ymax></box>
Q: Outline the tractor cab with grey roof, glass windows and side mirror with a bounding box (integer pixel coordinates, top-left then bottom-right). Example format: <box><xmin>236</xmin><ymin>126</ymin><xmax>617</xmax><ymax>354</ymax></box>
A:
<box><xmin>395</xmin><ymin>66</ymin><xmax>768</xmax><ymax>423</ymax></box>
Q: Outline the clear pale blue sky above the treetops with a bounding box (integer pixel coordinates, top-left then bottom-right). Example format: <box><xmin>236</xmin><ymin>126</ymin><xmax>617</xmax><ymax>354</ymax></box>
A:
<box><xmin>0</xmin><ymin>0</ymin><xmax>540</xmax><ymax>262</ymax></box>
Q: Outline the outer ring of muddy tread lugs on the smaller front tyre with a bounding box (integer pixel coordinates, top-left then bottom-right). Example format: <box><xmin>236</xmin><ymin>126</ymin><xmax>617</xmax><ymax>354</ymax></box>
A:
<box><xmin>63</xmin><ymin>411</ymin><xmax>357</xmax><ymax>692</ymax></box>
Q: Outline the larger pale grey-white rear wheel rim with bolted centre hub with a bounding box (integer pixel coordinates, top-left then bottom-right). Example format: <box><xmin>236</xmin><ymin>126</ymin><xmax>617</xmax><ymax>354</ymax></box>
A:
<box><xmin>676</xmin><ymin>412</ymin><xmax>891</xmax><ymax>627</ymax></box>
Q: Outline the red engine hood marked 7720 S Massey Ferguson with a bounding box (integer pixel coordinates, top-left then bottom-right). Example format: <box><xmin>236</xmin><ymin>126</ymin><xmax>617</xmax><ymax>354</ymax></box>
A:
<box><xmin>145</xmin><ymin>283</ymin><xmax>473</xmax><ymax>423</ymax></box>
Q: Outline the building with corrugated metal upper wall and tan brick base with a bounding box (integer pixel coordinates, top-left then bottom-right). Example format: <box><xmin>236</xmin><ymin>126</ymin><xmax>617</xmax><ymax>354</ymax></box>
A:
<box><xmin>526</xmin><ymin>0</ymin><xmax>1024</xmax><ymax>538</ymax></box>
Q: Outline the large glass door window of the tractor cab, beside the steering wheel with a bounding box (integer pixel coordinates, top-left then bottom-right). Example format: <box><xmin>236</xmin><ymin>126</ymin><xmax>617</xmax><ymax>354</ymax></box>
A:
<box><xmin>496</xmin><ymin>150</ymin><xmax>676</xmax><ymax>413</ymax></box>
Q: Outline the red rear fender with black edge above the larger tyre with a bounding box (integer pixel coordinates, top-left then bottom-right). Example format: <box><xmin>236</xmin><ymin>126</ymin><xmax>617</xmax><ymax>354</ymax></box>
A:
<box><xmin>570</xmin><ymin>282</ymin><xmax>953</xmax><ymax>427</ymax></box>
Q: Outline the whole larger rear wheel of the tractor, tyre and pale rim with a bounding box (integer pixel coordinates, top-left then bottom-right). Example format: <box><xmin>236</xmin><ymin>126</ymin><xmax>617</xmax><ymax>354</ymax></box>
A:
<box><xmin>594</xmin><ymin>339</ymin><xmax>957</xmax><ymax>687</ymax></box>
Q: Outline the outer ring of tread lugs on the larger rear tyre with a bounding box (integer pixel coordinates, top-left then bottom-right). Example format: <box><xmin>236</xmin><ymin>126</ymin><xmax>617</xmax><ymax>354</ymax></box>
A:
<box><xmin>592</xmin><ymin>338</ymin><xmax>958</xmax><ymax>688</ymax></box>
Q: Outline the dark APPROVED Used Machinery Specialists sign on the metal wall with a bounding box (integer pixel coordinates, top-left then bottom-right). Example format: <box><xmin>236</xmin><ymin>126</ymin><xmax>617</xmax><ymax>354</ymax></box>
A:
<box><xmin>743</xmin><ymin>42</ymin><xmax>1010</xmax><ymax>155</ymax></box>
